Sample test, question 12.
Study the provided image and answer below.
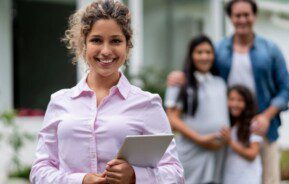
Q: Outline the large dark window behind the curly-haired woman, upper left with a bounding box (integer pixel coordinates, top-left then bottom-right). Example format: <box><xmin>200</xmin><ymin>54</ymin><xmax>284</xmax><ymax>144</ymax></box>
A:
<box><xmin>13</xmin><ymin>0</ymin><xmax>76</xmax><ymax>113</ymax></box>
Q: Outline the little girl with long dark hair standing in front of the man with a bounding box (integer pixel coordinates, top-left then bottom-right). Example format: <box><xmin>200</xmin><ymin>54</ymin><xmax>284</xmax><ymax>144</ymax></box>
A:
<box><xmin>221</xmin><ymin>85</ymin><xmax>263</xmax><ymax>184</ymax></box>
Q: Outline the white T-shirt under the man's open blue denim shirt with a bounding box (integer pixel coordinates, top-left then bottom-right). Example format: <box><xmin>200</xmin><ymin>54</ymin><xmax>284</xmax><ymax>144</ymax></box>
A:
<box><xmin>228</xmin><ymin>52</ymin><xmax>256</xmax><ymax>95</ymax></box>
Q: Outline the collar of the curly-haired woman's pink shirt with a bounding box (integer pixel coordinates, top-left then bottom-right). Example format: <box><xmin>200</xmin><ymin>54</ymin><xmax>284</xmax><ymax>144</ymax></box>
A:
<box><xmin>71</xmin><ymin>72</ymin><xmax>131</xmax><ymax>99</ymax></box>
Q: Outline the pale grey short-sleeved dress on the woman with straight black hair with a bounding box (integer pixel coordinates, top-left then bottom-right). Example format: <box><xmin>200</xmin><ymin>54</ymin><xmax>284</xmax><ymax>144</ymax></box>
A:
<box><xmin>165</xmin><ymin>72</ymin><xmax>229</xmax><ymax>184</ymax></box>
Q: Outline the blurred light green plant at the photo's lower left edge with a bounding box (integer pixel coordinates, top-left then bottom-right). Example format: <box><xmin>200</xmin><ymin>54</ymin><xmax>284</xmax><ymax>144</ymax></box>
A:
<box><xmin>0</xmin><ymin>111</ymin><xmax>34</xmax><ymax>179</ymax></box>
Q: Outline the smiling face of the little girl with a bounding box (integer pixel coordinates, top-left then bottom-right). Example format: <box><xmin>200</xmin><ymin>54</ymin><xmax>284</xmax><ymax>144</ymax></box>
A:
<box><xmin>228</xmin><ymin>90</ymin><xmax>246</xmax><ymax>117</ymax></box>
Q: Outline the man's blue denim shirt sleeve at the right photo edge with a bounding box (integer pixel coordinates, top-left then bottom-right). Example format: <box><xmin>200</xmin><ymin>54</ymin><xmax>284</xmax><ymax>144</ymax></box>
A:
<box><xmin>271</xmin><ymin>45</ymin><xmax>289</xmax><ymax>110</ymax></box>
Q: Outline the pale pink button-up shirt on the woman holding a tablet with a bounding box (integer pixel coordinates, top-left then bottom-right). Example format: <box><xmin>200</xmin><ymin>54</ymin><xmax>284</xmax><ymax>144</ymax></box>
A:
<box><xmin>30</xmin><ymin>74</ymin><xmax>184</xmax><ymax>184</ymax></box>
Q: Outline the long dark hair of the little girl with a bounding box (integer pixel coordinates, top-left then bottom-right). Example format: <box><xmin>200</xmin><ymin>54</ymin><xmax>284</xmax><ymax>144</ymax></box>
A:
<box><xmin>228</xmin><ymin>85</ymin><xmax>256</xmax><ymax>146</ymax></box>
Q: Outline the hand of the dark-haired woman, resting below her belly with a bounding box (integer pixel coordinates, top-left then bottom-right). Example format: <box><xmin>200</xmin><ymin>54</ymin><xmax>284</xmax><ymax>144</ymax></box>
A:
<box><xmin>196</xmin><ymin>134</ymin><xmax>224</xmax><ymax>150</ymax></box>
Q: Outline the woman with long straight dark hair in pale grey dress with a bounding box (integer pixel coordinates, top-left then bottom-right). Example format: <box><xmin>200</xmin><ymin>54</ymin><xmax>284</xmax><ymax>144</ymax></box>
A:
<box><xmin>165</xmin><ymin>35</ymin><xmax>229</xmax><ymax>184</ymax></box>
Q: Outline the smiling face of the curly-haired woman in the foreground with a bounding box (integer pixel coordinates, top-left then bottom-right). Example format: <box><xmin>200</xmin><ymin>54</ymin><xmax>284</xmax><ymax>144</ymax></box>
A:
<box><xmin>85</xmin><ymin>19</ymin><xmax>128</xmax><ymax>77</ymax></box>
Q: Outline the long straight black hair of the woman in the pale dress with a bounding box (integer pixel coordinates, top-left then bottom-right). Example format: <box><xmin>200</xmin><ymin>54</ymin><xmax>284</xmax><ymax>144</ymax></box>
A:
<box><xmin>179</xmin><ymin>34</ymin><xmax>217</xmax><ymax>116</ymax></box>
